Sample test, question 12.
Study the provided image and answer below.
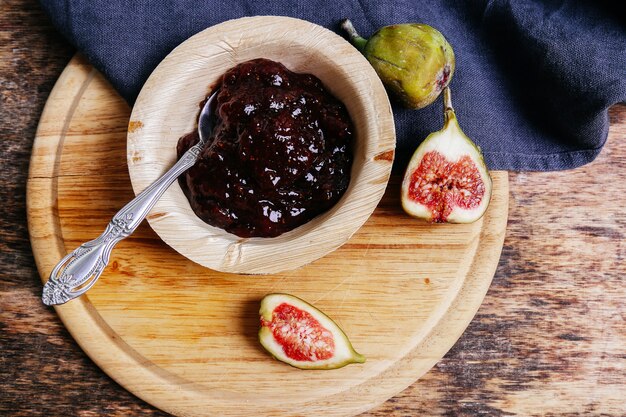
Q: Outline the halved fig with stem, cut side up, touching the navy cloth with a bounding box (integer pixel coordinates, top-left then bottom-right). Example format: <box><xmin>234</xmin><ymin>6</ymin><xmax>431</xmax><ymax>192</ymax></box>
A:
<box><xmin>401</xmin><ymin>87</ymin><xmax>492</xmax><ymax>223</ymax></box>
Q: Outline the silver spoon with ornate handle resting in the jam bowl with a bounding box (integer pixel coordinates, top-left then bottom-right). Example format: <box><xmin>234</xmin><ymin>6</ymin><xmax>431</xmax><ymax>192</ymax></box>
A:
<box><xmin>41</xmin><ymin>91</ymin><xmax>217</xmax><ymax>305</ymax></box>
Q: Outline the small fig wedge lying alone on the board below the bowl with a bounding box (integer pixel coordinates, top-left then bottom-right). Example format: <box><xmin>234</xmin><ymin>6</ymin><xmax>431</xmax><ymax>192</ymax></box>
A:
<box><xmin>259</xmin><ymin>294</ymin><xmax>365</xmax><ymax>369</ymax></box>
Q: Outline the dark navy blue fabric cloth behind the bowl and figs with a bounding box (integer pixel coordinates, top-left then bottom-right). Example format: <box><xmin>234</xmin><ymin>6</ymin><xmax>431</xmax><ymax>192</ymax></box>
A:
<box><xmin>41</xmin><ymin>0</ymin><xmax>626</xmax><ymax>170</ymax></box>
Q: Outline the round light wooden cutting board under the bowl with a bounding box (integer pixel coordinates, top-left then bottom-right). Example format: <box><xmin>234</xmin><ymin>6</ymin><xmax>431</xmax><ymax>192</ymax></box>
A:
<box><xmin>28</xmin><ymin>57</ymin><xmax>508</xmax><ymax>417</ymax></box>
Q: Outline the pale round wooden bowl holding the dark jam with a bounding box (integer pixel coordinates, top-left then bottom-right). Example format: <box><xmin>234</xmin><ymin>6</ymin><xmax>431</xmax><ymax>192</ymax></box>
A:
<box><xmin>127</xmin><ymin>16</ymin><xmax>395</xmax><ymax>274</ymax></box>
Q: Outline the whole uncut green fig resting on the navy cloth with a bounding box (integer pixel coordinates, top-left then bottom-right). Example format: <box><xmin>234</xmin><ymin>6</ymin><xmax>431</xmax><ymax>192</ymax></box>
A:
<box><xmin>341</xmin><ymin>19</ymin><xmax>454</xmax><ymax>109</ymax></box>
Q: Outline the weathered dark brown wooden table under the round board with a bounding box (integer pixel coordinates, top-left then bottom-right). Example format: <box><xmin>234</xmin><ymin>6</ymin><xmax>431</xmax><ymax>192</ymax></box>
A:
<box><xmin>0</xmin><ymin>0</ymin><xmax>626</xmax><ymax>417</ymax></box>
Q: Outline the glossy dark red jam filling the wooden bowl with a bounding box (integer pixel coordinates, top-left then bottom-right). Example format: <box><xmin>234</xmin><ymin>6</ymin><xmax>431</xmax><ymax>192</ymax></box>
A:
<box><xmin>177</xmin><ymin>59</ymin><xmax>354</xmax><ymax>237</ymax></box>
